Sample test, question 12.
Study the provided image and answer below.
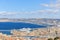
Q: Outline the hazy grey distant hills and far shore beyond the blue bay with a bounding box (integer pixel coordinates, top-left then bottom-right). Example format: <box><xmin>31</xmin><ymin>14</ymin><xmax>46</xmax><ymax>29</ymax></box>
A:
<box><xmin>0</xmin><ymin>18</ymin><xmax>60</xmax><ymax>25</ymax></box>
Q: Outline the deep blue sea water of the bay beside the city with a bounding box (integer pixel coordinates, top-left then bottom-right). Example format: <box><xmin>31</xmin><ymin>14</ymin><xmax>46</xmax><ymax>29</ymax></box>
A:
<box><xmin>0</xmin><ymin>22</ymin><xmax>46</xmax><ymax>34</ymax></box>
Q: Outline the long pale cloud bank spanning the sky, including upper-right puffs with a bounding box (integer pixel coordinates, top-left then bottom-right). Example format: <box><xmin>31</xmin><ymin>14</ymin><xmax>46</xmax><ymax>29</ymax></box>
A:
<box><xmin>0</xmin><ymin>0</ymin><xmax>60</xmax><ymax>15</ymax></box>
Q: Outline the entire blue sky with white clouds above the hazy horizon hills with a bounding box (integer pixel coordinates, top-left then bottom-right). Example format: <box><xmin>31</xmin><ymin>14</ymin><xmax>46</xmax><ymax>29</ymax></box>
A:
<box><xmin>0</xmin><ymin>0</ymin><xmax>60</xmax><ymax>19</ymax></box>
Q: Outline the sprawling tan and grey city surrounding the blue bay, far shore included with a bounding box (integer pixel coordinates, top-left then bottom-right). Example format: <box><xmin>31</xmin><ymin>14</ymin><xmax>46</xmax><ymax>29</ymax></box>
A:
<box><xmin>0</xmin><ymin>18</ymin><xmax>60</xmax><ymax>40</ymax></box>
